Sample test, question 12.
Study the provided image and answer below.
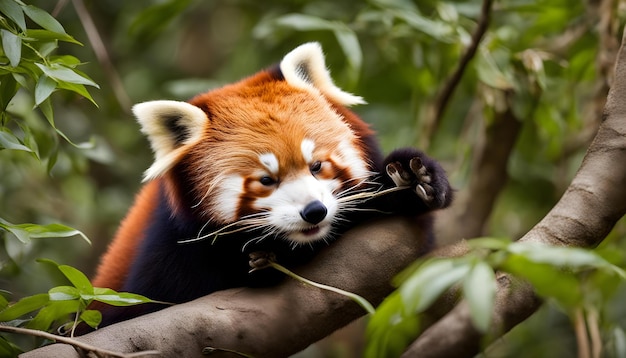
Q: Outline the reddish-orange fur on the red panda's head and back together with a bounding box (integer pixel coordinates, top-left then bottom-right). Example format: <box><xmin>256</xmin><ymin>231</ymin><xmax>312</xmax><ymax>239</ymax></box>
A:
<box><xmin>94</xmin><ymin>71</ymin><xmax>373</xmax><ymax>290</ymax></box>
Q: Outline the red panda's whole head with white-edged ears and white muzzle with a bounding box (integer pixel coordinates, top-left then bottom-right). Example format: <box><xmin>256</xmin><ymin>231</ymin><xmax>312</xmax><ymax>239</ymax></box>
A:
<box><xmin>134</xmin><ymin>44</ymin><xmax>371</xmax><ymax>244</ymax></box>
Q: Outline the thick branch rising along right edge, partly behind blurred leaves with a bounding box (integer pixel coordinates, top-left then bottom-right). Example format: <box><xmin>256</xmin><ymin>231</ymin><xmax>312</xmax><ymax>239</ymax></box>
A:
<box><xmin>405</xmin><ymin>25</ymin><xmax>626</xmax><ymax>357</ymax></box>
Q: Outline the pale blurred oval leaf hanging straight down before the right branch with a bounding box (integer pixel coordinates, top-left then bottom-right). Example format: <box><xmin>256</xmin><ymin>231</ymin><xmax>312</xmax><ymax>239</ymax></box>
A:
<box><xmin>463</xmin><ymin>262</ymin><xmax>496</xmax><ymax>332</ymax></box>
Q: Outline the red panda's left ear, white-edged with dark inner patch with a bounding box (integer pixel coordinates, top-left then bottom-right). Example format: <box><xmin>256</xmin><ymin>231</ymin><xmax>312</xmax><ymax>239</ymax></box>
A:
<box><xmin>133</xmin><ymin>101</ymin><xmax>208</xmax><ymax>181</ymax></box>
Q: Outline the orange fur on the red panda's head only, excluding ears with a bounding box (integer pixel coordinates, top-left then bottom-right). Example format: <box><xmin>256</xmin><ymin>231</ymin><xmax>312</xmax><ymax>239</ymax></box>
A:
<box><xmin>183</xmin><ymin>71</ymin><xmax>369</xmax><ymax>221</ymax></box>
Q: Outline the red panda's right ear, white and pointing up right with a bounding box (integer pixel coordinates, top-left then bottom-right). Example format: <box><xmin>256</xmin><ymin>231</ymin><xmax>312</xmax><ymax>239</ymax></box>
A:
<box><xmin>280</xmin><ymin>42</ymin><xmax>365</xmax><ymax>106</ymax></box>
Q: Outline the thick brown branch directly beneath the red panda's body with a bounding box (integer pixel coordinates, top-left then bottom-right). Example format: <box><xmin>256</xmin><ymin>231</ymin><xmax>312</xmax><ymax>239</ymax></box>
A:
<box><xmin>23</xmin><ymin>218</ymin><xmax>426</xmax><ymax>358</ymax></box>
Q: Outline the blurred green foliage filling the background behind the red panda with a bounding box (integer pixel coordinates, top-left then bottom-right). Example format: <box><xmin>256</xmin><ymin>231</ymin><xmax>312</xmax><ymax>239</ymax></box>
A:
<box><xmin>0</xmin><ymin>0</ymin><xmax>626</xmax><ymax>357</ymax></box>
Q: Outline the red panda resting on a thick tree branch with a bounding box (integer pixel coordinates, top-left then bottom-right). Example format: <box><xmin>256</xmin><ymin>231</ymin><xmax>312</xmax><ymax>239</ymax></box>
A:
<box><xmin>86</xmin><ymin>43</ymin><xmax>452</xmax><ymax>326</ymax></box>
